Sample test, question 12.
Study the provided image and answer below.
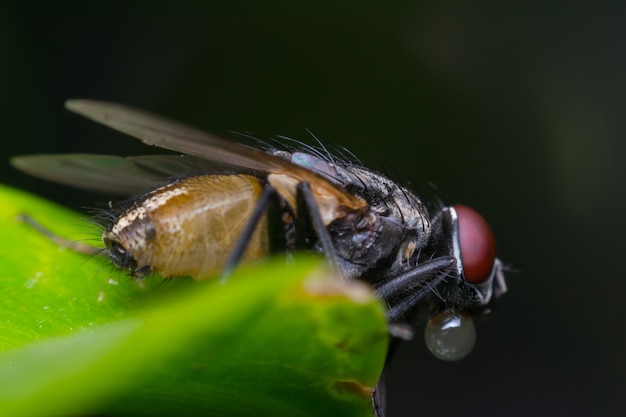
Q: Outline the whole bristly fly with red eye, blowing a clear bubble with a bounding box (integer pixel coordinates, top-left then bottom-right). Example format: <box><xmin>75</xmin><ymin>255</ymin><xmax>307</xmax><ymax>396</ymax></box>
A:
<box><xmin>12</xmin><ymin>100</ymin><xmax>506</xmax><ymax>415</ymax></box>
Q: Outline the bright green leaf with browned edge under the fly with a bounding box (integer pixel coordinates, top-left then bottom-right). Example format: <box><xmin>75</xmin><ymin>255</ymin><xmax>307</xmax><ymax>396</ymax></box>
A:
<box><xmin>0</xmin><ymin>186</ymin><xmax>387</xmax><ymax>417</ymax></box>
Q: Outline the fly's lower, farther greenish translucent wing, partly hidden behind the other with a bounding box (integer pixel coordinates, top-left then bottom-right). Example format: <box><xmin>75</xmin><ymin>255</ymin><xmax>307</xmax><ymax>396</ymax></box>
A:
<box><xmin>11</xmin><ymin>154</ymin><xmax>212</xmax><ymax>196</ymax></box>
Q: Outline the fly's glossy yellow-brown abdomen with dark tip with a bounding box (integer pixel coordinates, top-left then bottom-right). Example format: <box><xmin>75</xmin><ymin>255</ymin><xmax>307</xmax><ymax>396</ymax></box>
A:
<box><xmin>103</xmin><ymin>175</ymin><xmax>268</xmax><ymax>279</ymax></box>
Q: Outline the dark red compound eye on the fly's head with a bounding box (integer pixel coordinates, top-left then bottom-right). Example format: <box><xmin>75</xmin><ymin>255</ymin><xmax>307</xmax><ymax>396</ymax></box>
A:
<box><xmin>454</xmin><ymin>206</ymin><xmax>496</xmax><ymax>284</ymax></box>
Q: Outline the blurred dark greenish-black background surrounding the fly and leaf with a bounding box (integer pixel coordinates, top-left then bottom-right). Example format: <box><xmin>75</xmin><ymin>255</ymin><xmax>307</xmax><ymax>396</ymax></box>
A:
<box><xmin>0</xmin><ymin>4</ymin><xmax>626</xmax><ymax>417</ymax></box>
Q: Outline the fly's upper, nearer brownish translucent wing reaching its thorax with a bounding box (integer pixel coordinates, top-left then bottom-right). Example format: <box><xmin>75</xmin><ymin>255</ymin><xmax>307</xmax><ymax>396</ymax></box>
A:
<box><xmin>65</xmin><ymin>100</ymin><xmax>366</xmax><ymax>208</ymax></box>
